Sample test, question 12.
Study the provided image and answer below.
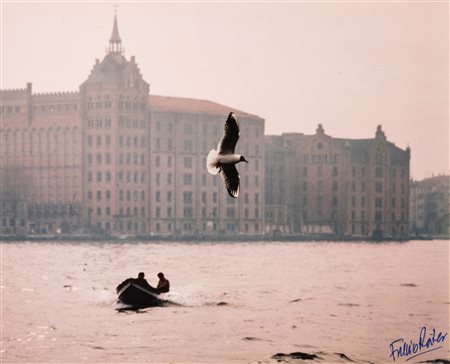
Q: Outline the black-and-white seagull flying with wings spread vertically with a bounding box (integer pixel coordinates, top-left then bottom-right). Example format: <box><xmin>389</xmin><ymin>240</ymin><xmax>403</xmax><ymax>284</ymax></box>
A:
<box><xmin>206</xmin><ymin>112</ymin><xmax>248</xmax><ymax>198</ymax></box>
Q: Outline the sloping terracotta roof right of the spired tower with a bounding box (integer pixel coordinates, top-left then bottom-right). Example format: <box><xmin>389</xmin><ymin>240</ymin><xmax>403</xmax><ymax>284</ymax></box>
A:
<box><xmin>149</xmin><ymin>95</ymin><xmax>259</xmax><ymax>118</ymax></box>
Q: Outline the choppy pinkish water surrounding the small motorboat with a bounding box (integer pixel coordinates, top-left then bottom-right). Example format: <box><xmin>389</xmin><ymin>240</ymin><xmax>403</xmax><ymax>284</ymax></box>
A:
<box><xmin>1</xmin><ymin>241</ymin><xmax>450</xmax><ymax>363</ymax></box>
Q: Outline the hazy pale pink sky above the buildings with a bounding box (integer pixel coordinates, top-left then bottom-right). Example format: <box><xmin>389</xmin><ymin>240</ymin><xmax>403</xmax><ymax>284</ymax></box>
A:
<box><xmin>1</xmin><ymin>1</ymin><xmax>449</xmax><ymax>179</ymax></box>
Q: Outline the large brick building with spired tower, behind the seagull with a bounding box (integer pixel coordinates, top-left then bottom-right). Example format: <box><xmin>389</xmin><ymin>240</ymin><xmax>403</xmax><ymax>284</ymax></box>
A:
<box><xmin>0</xmin><ymin>14</ymin><xmax>264</xmax><ymax>235</ymax></box>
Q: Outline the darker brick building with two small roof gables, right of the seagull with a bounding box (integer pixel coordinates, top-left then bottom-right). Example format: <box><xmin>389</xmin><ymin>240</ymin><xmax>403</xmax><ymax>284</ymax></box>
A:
<box><xmin>265</xmin><ymin>125</ymin><xmax>410</xmax><ymax>238</ymax></box>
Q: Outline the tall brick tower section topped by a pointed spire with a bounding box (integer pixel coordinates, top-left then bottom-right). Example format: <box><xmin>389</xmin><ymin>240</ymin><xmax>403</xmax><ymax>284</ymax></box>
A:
<box><xmin>80</xmin><ymin>15</ymin><xmax>150</xmax><ymax>235</ymax></box>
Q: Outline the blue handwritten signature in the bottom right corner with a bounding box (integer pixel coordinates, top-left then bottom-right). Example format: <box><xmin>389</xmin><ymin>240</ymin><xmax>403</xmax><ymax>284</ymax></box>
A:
<box><xmin>389</xmin><ymin>326</ymin><xmax>447</xmax><ymax>361</ymax></box>
